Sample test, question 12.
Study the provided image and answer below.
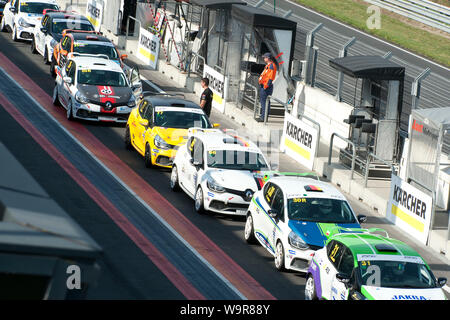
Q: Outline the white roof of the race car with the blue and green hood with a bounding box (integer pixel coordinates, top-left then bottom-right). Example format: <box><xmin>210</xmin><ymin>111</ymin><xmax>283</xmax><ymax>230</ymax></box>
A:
<box><xmin>267</xmin><ymin>176</ymin><xmax>347</xmax><ymax>200</ymax></box>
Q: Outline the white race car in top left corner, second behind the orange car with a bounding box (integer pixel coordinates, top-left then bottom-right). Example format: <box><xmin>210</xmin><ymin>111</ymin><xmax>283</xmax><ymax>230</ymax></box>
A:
<box><xmin>0</xmin><ymin>0</ymin><xmax>59</xmax><ymax>41</ymax></box>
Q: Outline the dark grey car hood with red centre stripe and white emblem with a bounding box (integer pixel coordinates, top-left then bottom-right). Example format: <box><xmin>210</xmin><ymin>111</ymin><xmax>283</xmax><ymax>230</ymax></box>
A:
<box><xmin>77</xmin><ymin>84</ymin><xmax>132</xmax><ymax>107</ymax></box>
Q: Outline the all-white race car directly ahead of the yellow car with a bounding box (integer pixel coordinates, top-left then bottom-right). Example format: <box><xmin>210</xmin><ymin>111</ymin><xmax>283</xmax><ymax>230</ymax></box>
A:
<box><xmin>170</xmin><ymin>128</ymin><xmax>270</xmax><ymax>216</ymax></box>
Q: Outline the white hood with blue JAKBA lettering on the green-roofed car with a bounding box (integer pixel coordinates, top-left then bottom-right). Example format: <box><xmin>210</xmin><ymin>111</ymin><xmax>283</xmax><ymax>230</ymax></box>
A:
<box><xmin>361</xmin><ymin>286</ymin><xmax>446</xmax><ymax>300</ymax></box>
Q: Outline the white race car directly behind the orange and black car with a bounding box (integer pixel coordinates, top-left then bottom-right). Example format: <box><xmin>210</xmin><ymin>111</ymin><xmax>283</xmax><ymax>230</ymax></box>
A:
<box><xmin>31</xmin><ymin>10</ymin><xmax>94</xmax><ymax>63</ymax></box>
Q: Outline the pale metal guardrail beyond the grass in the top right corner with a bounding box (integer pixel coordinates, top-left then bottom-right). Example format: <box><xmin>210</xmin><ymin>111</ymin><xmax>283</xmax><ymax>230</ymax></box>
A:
<box><xmin>364</xmin><ymin>0</ymin><xmax>450</xmax><ymax>33</ymax></box>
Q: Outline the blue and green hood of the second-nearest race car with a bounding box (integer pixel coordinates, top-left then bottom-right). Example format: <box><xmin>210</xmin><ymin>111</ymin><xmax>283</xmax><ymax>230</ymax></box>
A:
<box><xmin>288</xmin><ymin>220</ymin><xmax>361</xmax><ymax>247</ymax></box>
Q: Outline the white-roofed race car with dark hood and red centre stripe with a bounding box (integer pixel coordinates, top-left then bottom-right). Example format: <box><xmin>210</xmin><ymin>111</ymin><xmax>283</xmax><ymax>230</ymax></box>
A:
<box><xmin>53</xmin><ymin>53</ymin><xmax>142</xmax><ymax>123</ymax></box>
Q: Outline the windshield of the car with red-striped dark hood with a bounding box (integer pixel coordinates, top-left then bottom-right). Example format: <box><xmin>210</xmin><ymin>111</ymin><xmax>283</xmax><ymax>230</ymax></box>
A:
<box><xmin>78</xmin><ymin>69</ymin><xmax>128</xmax><ymax>87</ymax></box>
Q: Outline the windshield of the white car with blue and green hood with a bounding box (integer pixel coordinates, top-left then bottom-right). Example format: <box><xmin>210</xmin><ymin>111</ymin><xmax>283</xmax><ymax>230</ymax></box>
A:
<box><xmin>288</xmin><ymin>198</ymin><xmax>356</xmax><ymax>223</ymax></box>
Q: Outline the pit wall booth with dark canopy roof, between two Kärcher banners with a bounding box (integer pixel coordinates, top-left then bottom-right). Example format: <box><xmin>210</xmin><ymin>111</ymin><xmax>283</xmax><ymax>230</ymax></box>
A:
<box><xmin>329</xmin><ymin>56</ymin><xmax>405</xmax><ymax>179</ymax></box>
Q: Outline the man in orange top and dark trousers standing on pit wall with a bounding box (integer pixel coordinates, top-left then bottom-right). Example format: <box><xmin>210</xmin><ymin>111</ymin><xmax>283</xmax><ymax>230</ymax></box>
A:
<box><xmin>256</xmin><ymin>52</ymin><xmax>277</xmax><ymax>122</ymax></box>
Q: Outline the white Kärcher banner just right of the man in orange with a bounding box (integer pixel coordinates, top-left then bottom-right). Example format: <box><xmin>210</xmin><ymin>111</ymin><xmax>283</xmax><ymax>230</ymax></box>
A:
<box><xmin>280</xmin><ymin>113</ymin><xmax>319</xmax><ymax>170</ymax></box>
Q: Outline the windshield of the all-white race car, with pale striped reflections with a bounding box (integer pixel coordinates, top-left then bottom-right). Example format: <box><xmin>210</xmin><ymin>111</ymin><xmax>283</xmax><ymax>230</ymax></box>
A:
<box><xmin>207</xmin><ymin>150</ymin><xmax>269</xmax><ymax>171</ymax></box>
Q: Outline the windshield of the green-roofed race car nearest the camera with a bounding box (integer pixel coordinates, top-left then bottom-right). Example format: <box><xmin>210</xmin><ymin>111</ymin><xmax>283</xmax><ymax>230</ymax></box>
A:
<box><xmin>359</xmin><ymin>260</ymin><xmax>436</xmax><ymax>289</ymax></box>
